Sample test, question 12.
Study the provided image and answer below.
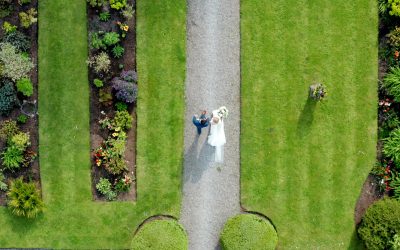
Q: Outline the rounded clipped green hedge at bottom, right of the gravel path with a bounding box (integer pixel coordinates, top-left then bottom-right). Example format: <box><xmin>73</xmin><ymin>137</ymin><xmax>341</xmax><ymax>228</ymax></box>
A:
<box><xmin>220</xmin><ymin>214</ymin><xmax>278</xmax><ymax>250</ymax></box>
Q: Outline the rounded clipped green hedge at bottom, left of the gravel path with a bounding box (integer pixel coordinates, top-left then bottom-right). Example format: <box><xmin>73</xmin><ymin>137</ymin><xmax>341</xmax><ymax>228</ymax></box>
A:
<box><xmin>131</xmin><ymin>219</ymin><xmax>188</xmax><ymax>250</ymax></box>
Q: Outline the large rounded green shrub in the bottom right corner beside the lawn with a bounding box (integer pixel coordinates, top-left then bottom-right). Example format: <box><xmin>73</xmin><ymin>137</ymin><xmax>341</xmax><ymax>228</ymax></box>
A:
<box><xmin>358</xmin><ymin>198</ymin><xmax>400</xmax><ymax>249</ymax></box>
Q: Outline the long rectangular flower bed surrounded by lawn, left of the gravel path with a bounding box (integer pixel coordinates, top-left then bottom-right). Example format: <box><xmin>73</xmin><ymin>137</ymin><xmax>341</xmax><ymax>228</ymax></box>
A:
<box><xmin>87</xmin><ymin>0</ymin><xmax>138</xmax><ymax>201</ymax></box>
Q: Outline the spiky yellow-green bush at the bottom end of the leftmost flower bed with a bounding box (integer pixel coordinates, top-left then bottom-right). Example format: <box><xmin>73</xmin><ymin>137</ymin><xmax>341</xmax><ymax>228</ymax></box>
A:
<box><xmin>7</xmin><ymin>178</ymin><xmax>44</xmax><ymax>218</ymax></box>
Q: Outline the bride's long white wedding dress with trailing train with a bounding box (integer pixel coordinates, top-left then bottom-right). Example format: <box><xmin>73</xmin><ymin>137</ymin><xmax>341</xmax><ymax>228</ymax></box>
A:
<box><xmin>207</xmin><ymin>110</ymin><xmax>226</xmax><ymax>162</ymax></box>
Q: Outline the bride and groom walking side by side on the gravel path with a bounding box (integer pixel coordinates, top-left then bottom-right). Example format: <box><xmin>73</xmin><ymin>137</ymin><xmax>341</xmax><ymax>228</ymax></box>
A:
<box><xmin>193</xmin><ymin>106</ymin><xmax>228</xmax><ymax>162</ymax></box>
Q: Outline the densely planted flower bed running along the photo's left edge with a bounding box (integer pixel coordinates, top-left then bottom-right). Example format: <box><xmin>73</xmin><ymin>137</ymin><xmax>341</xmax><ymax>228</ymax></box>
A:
<box><xmin>0</xmin><ymin>0</ymin><xmax>41</xmax><ymax>217</ymax></box>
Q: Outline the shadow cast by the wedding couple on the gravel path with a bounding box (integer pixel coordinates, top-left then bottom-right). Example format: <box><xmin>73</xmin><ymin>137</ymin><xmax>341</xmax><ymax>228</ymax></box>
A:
<box><xmin>184</xmin><ymin>133</ymin><xmax>213</xmax><ymax>183</ymax></box>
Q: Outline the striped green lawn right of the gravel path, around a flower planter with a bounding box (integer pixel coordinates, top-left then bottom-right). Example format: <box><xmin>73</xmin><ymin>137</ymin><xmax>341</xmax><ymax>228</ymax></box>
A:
<box><xmin>241</xmin><ymin>0</ymin><xmax>378</xmax><ymax>249</ymax></box>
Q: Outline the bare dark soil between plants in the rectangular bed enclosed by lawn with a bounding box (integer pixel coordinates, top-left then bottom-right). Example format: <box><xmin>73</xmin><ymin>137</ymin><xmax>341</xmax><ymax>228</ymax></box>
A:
<box><xmin>87</xmin><ymin>0</ymin><xmax>136</xmax><ymax>201</ymax></box>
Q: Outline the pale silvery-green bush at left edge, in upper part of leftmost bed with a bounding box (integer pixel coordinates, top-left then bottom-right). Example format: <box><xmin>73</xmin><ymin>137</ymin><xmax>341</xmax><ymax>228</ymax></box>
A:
<box><xmin>0</xmin><ymin>43</ymin><xmax>34</xmax><ymax>82</ymax></box>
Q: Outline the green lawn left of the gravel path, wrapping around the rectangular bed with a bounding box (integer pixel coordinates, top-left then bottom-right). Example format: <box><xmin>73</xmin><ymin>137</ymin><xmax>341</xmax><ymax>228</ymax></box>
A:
<box><xmin>0</xmin><ymin>0</ymin><xmax>186</xmax><ymax>249</ymax></box>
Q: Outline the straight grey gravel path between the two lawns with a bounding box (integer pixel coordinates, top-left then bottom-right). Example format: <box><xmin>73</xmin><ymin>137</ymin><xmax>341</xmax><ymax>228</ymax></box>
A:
<box><xmin>181</xmin><ymin>0</ymin><xmax>240</xmax><ymax>250</ymax></box>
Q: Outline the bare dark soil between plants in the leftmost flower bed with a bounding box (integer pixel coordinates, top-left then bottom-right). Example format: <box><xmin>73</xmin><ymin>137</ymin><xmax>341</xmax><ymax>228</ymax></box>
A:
<box><xmin>0</xmin><ymin>0</ymin><xmax>41</xmax><ymax>206</ymax></box>
